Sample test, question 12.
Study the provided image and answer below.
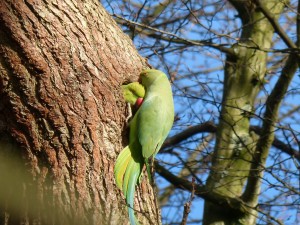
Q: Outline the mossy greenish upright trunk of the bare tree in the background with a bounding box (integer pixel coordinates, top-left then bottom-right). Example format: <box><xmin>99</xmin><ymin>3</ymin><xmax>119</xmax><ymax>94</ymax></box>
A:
<box><xmin>203</xmin><ymin>0</ymin><xmax>284</xmax><ymax>225</ymax></box>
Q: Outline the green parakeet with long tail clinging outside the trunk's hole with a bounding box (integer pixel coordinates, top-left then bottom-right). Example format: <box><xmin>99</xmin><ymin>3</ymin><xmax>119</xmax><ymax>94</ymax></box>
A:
<box><xmin>114</xmin><ymin>69</ymin><xmax>174</xmax><ymax>225</ymax></box>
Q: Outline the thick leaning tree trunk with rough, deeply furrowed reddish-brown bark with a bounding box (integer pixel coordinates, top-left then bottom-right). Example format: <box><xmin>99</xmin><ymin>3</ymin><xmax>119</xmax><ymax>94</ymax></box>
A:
<box><xmin>0</xmin><ymin>0</ymin><xmax>159</xmax><ymax>225</ymax></box>
